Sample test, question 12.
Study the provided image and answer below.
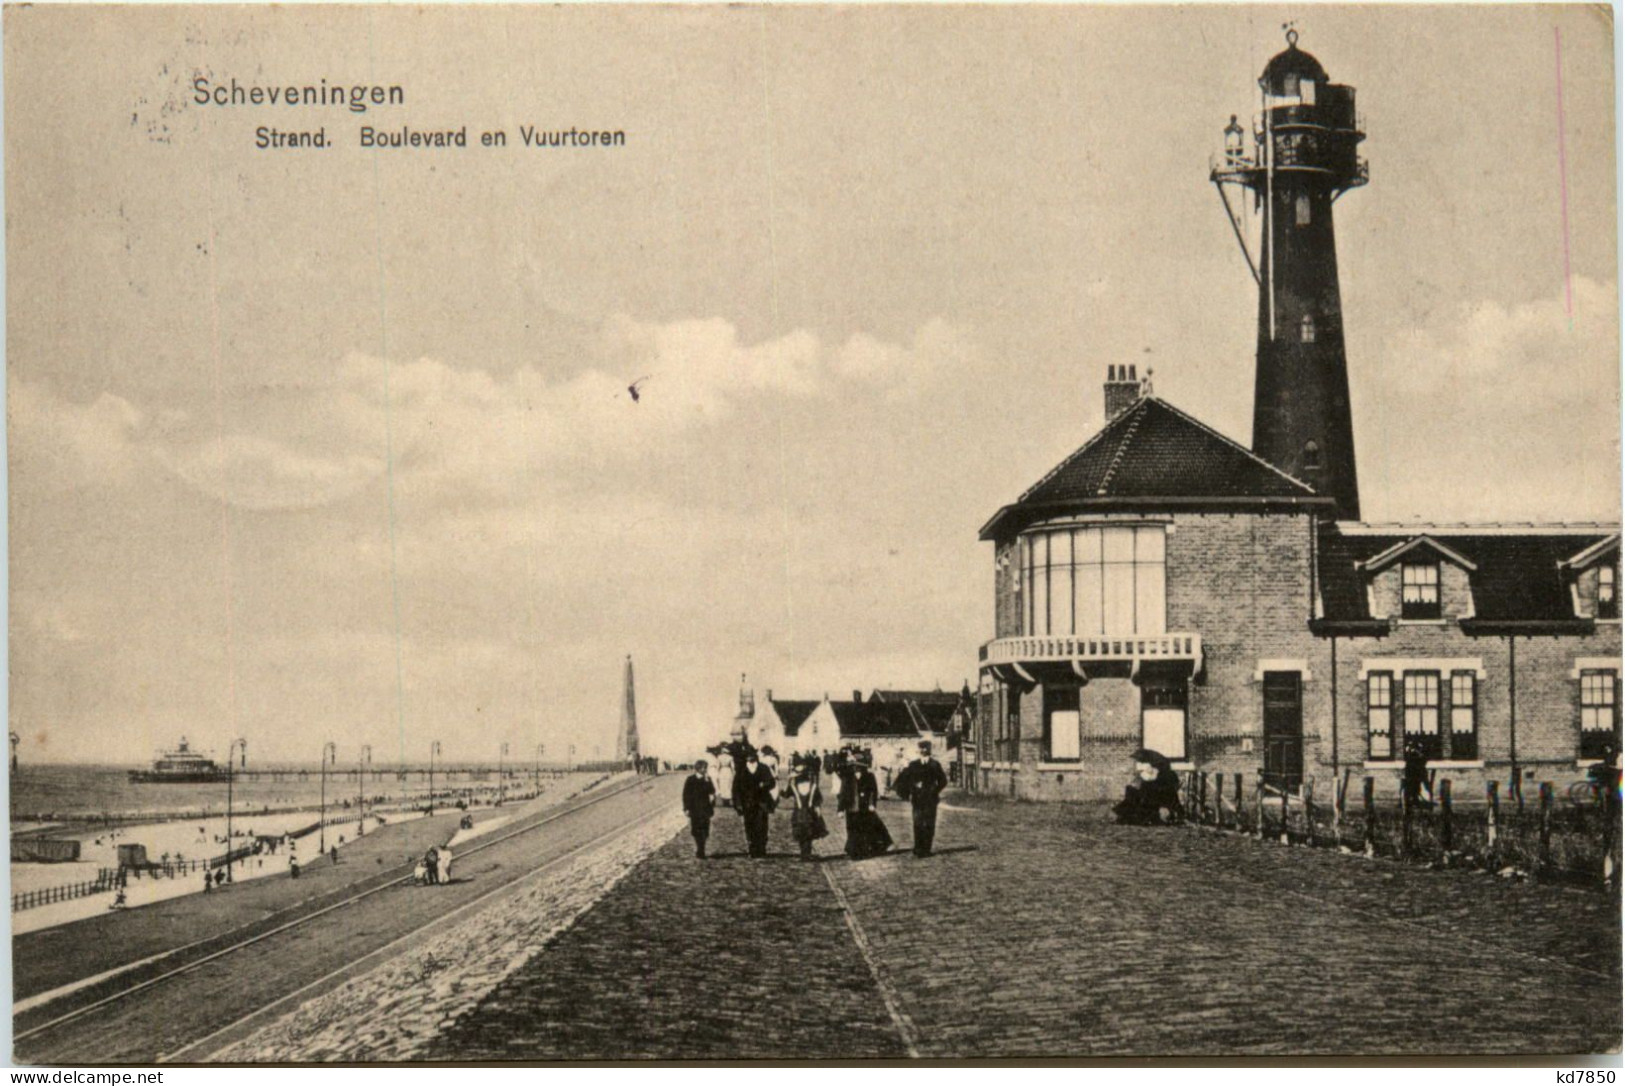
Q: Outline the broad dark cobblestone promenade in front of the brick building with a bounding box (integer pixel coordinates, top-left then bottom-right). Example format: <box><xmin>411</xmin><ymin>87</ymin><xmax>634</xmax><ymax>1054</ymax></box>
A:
<box><xmin>423</xmin><ymin>797</ymin><xmax>1620</xmax><ymax>1060</ymax></box>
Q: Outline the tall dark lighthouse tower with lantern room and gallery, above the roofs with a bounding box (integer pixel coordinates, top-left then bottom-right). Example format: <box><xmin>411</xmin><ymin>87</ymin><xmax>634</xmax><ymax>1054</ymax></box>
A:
<box><xmin>1212</xmin><ymin>29</ymin><xmax>1367</xmax><ymax>520</ymax></box>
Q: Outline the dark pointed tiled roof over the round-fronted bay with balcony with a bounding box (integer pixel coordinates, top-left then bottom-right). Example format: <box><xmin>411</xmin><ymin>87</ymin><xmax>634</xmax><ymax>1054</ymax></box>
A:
<box><xmin>982</xmin><ymin>397</ymin><xmax>1331</xmax><ymax>540</ymax></box>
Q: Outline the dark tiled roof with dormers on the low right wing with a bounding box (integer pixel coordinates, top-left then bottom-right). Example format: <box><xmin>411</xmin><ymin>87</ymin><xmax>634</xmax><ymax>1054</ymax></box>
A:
<box><xmin>1318</xmin><ymin>523</ymin><xmax>1610</xmax><ymax>624</ymax></box>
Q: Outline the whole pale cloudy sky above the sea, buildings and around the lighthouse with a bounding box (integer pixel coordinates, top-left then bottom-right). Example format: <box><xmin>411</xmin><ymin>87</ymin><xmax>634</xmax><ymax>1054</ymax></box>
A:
<box><xmin>5</xmin><ymin>5</ymin><xmax>1620</xmax><ymax>762</ymax></box>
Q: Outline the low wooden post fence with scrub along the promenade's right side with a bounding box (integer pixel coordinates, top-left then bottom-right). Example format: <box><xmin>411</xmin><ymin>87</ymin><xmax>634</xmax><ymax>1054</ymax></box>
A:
<box><xmin>1181</xmin><ymin>771</ymin><xmax>1620</xmax><ymax>888</ymax></box>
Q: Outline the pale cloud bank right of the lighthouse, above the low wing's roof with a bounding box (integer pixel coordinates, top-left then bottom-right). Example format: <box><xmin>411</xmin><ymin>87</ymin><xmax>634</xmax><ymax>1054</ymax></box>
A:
<box><xmin>1355</xmin><ymin>278</ymin><xmax>1620</xmax><ymax>520</ymax></box>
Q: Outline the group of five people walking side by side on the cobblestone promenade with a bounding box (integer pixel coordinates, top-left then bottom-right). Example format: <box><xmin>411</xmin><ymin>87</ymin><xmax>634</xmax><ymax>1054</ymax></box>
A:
<box><xmin>683</xmin><ymin>741</ymin><xmax>947</xmax><ymax>860</ymax></box>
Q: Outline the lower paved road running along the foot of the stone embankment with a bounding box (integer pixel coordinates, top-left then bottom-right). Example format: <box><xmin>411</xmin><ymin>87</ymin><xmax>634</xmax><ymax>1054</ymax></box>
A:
<box><xmin>16</xmin><ymin>777</ymin><xmax>659</xmax><ymax>1063</ymax></box>
